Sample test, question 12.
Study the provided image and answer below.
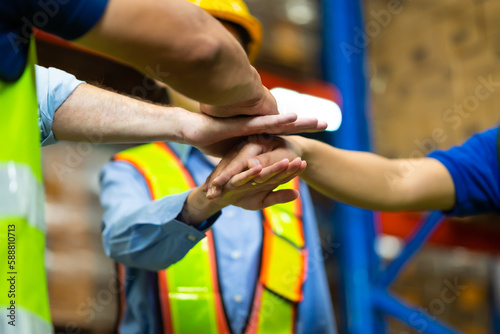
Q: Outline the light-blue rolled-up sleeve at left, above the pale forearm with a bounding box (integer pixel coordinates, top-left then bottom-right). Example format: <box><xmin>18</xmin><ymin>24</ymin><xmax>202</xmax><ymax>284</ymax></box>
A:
<box><xmin>35</xmin><ymin>66</ymin><xmax>85</xmax><ymax>146</ymax></box>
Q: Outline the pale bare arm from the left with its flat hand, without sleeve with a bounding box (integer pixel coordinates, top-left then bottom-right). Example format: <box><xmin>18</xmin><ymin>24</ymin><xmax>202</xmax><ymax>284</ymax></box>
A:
<box><xmin>52</xmin><ymin>84</ymin><xmax>325</xmax><ymax>156</ymax></box>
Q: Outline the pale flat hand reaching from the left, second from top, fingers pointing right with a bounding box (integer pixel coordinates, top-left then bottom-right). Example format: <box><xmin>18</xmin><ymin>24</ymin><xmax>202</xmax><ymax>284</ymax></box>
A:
<box><xmin>179</xmin><ymin>109</ymin><xmax>327</xmax><ymax>157</ymax></box>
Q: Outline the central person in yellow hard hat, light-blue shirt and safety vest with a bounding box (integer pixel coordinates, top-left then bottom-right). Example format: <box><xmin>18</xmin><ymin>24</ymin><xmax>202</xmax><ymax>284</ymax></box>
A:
<box><xmin>100</xmin><ymin>0</ymin><xmax>336</xmax><ymax>334</ymax></box>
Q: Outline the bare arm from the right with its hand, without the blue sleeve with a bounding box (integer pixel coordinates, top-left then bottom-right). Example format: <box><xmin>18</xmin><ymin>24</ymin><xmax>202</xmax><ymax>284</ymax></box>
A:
<box><xmin>209</xmin><ymin>136</ymin><xmax>455</xmax><ymax>211</ymax></box>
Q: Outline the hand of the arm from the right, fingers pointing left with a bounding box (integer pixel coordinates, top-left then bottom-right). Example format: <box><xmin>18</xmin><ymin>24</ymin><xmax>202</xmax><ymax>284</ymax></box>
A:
<box><xmin>204</xmin><ymin>135</ymin><xmax>302</xmax><ymax>198</ymax></box>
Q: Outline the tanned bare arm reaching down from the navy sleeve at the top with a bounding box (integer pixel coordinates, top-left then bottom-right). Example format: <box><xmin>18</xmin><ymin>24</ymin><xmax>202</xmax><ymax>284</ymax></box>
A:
<box><xmin>77</xmin><ymin>0</ymin><xmax>277</xmax><ymax>116</ymax></box>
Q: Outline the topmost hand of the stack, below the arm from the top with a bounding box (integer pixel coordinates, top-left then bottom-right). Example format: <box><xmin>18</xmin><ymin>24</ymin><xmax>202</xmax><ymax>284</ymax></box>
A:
<box><xmin>200</xmin><ymin>86</ymin><xmax>279</xmax><ymax>118</ymax></box>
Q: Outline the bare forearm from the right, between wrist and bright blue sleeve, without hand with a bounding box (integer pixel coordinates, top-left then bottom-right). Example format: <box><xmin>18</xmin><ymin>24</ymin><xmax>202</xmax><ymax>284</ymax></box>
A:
<box><xmin>292</xmin><ymin>137</ymin><xmax>454</xmax><ymax>211</ymax></box>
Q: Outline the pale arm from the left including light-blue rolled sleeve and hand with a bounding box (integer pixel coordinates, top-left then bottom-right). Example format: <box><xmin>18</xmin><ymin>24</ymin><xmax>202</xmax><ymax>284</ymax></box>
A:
<box><xmin>36</xmin><ymin>66</ymin><xmax>326</xmax><ymax>156</ymax></box>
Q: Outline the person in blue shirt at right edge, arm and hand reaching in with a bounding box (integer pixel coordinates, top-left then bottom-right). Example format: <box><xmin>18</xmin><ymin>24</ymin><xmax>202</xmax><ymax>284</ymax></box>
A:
<box><xmin>208</xmin><ymin>127</ymin><xmax>500</xmax><ymax>216</ymax></box>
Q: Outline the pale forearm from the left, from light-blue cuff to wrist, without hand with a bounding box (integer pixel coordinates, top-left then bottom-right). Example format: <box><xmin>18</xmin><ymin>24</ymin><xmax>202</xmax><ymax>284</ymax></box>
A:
<box><xmin>52</xmin><ymin>84</ymin><xmax>188</xmax><ymax>143</ymax></box>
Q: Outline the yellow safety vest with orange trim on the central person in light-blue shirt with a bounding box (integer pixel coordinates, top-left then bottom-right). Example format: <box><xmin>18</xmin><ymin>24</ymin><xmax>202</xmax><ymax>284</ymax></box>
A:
<box><xmin>115</xmin><ymin>143</ymin><xmax>307</xmax><ymax>334</ymax></box>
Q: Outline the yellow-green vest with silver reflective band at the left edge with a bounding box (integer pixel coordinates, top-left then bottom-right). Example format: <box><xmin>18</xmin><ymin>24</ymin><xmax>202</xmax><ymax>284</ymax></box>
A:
<box><xmin>0</xmin><ymin>40</ymin><xmax>53</xmax><ymax>334</ymax></box>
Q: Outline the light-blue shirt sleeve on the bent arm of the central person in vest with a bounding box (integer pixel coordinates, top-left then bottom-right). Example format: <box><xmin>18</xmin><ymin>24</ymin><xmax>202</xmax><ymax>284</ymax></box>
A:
<box><xmin>100</xmin><ymin>161</ymin><xmax>220</xmax><ymax>271</ymax></box>
